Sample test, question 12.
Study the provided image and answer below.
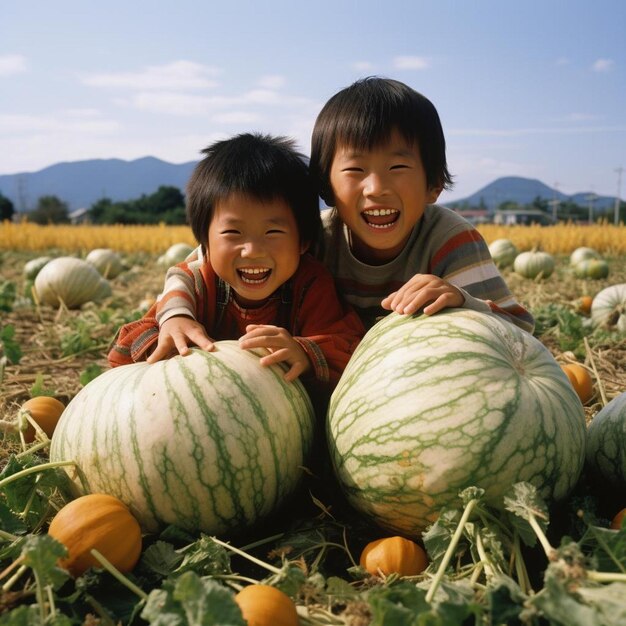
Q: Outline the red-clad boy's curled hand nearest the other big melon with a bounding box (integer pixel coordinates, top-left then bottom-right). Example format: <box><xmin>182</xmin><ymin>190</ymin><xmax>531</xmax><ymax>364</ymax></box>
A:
<box><xmin>239</xmin><ymin>324</ymin><xmax>311</xmax><ymax>382</ymax></box>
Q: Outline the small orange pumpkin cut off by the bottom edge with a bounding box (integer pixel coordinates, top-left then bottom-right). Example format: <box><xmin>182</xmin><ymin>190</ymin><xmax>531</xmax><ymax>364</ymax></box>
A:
<box><xmin>235</xmin><ymin>585</ymin><xmax>299</xmax><ymax>626</ymax></box>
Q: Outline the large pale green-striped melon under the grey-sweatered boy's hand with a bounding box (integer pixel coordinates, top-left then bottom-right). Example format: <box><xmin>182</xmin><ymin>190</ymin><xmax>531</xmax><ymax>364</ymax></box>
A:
<box><xmin>327</xmin><ymin>309</ymin><xmax>585</xmax><ymax>537</ymax></box>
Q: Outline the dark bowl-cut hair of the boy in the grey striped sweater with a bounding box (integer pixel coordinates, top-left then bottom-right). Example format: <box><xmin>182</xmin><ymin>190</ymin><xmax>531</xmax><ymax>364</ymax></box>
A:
<box><xmin>310</xmin><ymin>76</ymin><xmax>452</xmax><ymax>206</ymax></box>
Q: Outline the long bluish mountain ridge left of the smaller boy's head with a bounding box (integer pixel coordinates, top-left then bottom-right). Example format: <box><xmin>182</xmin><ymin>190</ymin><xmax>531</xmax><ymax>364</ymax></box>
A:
<box><xmin>0</xmin><ymin>157</ymin><xmax>196</xmax><ymax>212</ymax></box>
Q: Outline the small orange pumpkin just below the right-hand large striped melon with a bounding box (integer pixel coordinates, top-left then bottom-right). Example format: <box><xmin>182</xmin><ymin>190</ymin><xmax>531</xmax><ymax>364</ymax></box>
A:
<box><xmin>359</xmin><ymin>536</ymin><xmax>428</xmax><ymax>576</ymax></box>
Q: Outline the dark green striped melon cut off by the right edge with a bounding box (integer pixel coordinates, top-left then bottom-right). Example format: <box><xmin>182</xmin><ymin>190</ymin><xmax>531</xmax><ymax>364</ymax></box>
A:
<box><xmin>587</xmin><ymin>391</ymin><xmax>626</xmax><ymax>491</ymax></box>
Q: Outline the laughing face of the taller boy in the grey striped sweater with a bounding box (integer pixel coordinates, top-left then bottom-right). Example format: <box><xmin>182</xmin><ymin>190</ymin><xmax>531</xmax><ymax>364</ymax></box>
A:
<box><xmin>330</xmin><ymin>130</ymin><xmax>441</xmax><ymax>265</ymax></box>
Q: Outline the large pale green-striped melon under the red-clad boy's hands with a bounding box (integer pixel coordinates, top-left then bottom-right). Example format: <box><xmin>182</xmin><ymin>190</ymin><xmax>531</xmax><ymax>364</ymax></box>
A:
<box><xmin>50</xmin><ymin>341</ymin><xmax>314</xmax><ymax>534</ymax></box>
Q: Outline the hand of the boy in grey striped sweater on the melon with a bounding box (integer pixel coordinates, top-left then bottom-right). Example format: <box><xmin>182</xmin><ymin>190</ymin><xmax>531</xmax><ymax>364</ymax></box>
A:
<box><xmin>381</xmin><ymin>274</ymin><xmax>465</xmax><ymax>315</ymax></box>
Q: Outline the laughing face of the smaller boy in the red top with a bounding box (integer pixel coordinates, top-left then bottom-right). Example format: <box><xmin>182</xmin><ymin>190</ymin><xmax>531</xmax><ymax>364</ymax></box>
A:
<box><xmin>208</xmin><ymin>193</ymin><xmax>306</xmax><ymax>307</ymax></box>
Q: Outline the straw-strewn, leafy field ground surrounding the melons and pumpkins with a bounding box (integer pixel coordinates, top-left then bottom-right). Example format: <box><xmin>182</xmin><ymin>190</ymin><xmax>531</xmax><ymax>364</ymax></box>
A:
<box><xmin>0</xmin><ymin>252</ymin><xmax>626</xmax><ymax>626</ymax></box>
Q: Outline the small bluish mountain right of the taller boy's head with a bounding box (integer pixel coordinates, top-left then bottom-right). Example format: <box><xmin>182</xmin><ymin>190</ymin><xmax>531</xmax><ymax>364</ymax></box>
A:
<box><xmin>446</xmin><ymin>176</ymin><xmax>615</xmax><ymax>211</ymax></box>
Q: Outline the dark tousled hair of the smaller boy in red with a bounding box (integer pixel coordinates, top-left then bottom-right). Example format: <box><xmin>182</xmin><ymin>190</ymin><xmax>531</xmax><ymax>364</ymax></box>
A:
<box><xmin>186</xmin><ymin>133</ymin><xmax>322</xmax><ymax>252</ymax></box>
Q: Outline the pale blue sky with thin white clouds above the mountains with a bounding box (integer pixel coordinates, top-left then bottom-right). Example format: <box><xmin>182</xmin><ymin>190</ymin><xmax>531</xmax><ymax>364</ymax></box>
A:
<box><xmin>0</xmin><ymin>0</ymin><xmax>626</xmax><ymax>201</ymax></box>
